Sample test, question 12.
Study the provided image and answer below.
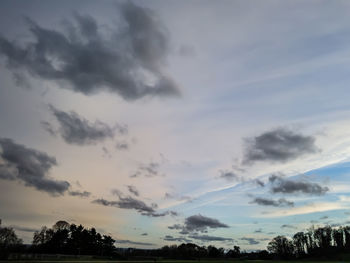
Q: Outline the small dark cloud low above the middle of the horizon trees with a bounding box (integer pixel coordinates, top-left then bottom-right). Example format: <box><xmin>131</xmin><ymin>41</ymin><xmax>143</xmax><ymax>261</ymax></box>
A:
<box><xmin>184</xmin><ymin>214</ymin><xmax>229</xmax><ymax>232</ymax></box>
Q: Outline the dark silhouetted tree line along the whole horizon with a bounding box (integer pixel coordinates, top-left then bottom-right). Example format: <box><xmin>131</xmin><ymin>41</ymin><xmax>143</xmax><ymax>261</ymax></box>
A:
<box><xmin>0</xmin><ymin>220</ymin><xmax>350</xmax><ymax>259</ymax></box>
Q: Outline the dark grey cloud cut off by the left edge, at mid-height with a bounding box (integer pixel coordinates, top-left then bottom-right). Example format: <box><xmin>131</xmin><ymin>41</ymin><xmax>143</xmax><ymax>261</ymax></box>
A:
<box><xmin>0</xmin><ymin>138</ymin><xmax>70</xmax><ymax>196</ymax></box>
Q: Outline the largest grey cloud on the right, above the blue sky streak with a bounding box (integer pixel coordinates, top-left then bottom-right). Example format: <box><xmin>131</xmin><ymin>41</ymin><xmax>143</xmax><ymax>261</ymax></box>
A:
<box><xmin>243</xmin><ymin>128</ymin><xmax>318</xmax><ymax>164</ymax></box>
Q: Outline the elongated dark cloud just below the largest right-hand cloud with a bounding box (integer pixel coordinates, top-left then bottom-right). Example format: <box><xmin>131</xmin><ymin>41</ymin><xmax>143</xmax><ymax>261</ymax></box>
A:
<box><xmin>269</xmin><ymin>175</ymin><xmax>329</xmax><ymax>195</ymax></box>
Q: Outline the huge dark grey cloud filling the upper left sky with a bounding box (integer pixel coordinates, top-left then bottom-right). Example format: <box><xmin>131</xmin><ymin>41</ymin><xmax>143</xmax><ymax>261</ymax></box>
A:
<box><xmin>0</xmin><ymin>1</ymin><xmax>180</xmax><ymax>100</ymax></box>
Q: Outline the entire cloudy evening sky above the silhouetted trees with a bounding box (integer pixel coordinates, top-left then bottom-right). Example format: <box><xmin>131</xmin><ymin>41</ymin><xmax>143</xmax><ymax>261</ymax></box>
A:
<box><xmin>0</xmin><ymin>0</ymin><xmax>350</xmax><ymax>250</ymax></box>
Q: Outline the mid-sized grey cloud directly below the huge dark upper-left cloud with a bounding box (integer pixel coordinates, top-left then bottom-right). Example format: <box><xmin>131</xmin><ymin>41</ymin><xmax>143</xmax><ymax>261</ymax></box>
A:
<box><xmin>45</xmin><ymin>105</ymin><xmax>128</xmax><ymax>145</ymax></box>
